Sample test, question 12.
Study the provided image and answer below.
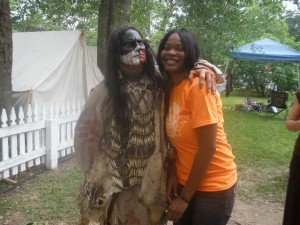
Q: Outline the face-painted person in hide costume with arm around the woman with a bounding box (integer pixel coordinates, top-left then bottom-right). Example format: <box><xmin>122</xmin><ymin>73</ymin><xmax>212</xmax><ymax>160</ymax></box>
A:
<box><xmin>74</xmin><ymin>27</ymin><xmax>224</xmax><ymax>225</ymax></box>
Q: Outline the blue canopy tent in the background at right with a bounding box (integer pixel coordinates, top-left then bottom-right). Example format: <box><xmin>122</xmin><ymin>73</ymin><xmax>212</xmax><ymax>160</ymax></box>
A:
<box><xmin>229</xmin><ymin>38</ymin><xmax>300</xmax><ymax>87</ymax></box>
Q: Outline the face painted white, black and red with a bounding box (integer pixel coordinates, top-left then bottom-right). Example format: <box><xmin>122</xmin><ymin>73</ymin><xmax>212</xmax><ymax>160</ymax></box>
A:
<box><xmin>120</xmin><ymin>29</ymin><xmax>146</xmax><ymax>66</ymax></box>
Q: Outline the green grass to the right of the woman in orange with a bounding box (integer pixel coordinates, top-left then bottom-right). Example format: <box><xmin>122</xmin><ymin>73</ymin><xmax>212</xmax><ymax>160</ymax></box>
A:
<box><xmin>222</xmin><ymin>96</ymin><xmax>297</xmax><ymax>203</ymax></box>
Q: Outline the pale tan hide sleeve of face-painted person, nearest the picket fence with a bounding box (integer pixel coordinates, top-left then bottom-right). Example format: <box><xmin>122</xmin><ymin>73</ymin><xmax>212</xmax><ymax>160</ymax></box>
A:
<box><xmin>74</xmin><ymin>82</ymin><xmax>107</xmax><ymax>172</ymax></box>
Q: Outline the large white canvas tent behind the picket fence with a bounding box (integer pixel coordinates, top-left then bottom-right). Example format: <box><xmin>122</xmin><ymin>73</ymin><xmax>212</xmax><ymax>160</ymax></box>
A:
<box><xmin>12</xmin><ymin>31</ymin><xmax>103</xmax><ymax>108</ymax></box>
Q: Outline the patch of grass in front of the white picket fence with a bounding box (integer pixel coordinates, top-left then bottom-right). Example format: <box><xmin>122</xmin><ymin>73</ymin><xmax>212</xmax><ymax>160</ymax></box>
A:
<box><xmin>0</xmin><ymin>163</ymin><xmax>83</xmax><ymax>225</ymax></box>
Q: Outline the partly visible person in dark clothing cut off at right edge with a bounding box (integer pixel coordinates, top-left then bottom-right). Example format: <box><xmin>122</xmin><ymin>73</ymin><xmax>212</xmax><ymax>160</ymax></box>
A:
<box><xmin>283</xmin><ymin>90</ymin><xmax>300</xmax><ymax>225</ymax></box>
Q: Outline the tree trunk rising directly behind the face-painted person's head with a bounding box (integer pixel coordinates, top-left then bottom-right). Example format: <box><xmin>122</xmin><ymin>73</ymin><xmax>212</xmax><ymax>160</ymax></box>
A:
<box><xmin>97</xmin><ymin>0</ymin><xmax>131</xmax><ymax>76</ymax></box>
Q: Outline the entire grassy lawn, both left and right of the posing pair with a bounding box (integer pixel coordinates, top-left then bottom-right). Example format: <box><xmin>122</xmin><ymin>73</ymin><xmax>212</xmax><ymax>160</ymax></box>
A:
<box><xmin>0</xmin><ymin>92</ymin><xmax>297</xmax><ymax>225</ymax></box>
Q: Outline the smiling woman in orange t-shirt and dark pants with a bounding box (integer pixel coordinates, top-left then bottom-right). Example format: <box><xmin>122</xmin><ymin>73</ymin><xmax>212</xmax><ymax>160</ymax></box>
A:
<box><xmin>157</xmin><ymin>29</ymin><xmax>237</xmax><ymax>225</ymax></box>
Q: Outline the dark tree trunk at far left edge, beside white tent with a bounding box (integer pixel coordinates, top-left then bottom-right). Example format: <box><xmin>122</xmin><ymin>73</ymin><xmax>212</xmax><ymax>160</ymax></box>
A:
<box><xmin>0</xmin><ymin>0</ymin><xmax>12</xmax><ymax>110</ymax></box>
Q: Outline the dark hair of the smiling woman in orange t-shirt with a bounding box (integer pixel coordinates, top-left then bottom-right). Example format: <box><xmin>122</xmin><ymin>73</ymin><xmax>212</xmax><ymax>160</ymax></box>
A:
<box><xmin>157</xmin><ymin>28</ymin><xmax>200</xmax><ymax>115</ymax></box>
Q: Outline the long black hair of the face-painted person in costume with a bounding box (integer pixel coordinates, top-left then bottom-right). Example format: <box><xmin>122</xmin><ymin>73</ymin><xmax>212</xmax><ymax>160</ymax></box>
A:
<box><xmin>105</xmin><ymin>27</ymin><xmax>155</xmax><ymax>123</ymax></box>
